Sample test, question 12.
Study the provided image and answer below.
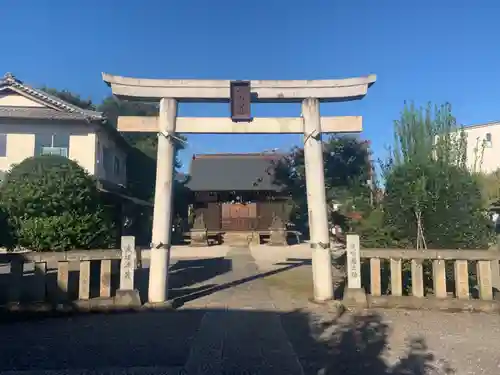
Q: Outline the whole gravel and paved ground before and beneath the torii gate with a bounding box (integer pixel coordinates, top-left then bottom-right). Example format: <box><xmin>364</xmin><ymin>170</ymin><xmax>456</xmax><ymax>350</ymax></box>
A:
<box><xmin>0</xmin><ymin>248</ymin><xmax>500</xmax><ymax>375</ymax></box>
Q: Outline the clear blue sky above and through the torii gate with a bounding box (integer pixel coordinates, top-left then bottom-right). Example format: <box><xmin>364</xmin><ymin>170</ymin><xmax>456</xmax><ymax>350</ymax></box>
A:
<box><xmin>0</xmin><ymin>0</ymin><xmax>500</xmax><ymax>172</ymax></box>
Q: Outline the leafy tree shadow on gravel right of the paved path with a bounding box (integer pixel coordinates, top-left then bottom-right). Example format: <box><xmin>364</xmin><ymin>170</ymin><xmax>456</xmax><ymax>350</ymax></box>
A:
<box><xmin>282</xmin><ymin>312</ymin><xmax>455</xmax><ymax>375</ymax></box>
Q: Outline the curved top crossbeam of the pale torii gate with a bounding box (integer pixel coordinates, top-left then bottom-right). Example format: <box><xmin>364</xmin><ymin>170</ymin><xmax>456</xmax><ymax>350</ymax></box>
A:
<box><xmin>102</xmin><ymin>73</ymin><xmax>377</xmax><ymax>103</ymax></box>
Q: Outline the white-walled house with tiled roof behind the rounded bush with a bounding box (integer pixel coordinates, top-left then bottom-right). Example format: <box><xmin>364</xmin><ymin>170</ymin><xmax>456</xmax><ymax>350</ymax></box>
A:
<box><xmin>0</xmin><ymin>73</ymin><xmax>127</xmax><ymax>186</ymax></box>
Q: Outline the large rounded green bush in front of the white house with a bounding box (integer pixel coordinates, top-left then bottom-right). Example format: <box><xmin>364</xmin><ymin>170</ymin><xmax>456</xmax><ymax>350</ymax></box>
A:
<box><xmin>0</xmin><ymin>155</ymin><xmax>116</xmax><ymax>251</ymax></box>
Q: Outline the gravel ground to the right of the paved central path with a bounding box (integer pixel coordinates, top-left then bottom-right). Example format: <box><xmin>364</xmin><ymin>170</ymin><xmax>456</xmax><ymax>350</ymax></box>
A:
<box><xmin>267</xmin><ymin>266</ymin><xmax>500</xmax><ymax>375</ymax></box>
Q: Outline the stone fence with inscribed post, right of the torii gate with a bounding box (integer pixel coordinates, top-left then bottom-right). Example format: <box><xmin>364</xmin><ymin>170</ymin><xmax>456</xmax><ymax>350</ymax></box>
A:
<box><xmin>344</xmin><ymin>235</ymin><xmax>500</xmax><ymax>311</ymax></box>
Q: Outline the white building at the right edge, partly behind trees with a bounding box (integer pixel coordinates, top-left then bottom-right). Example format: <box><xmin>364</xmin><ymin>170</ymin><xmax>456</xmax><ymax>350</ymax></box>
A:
<box><xmin>464</xmin><ymin>121</ymin><xmax>500</xmax><ymax>173</ymax></box>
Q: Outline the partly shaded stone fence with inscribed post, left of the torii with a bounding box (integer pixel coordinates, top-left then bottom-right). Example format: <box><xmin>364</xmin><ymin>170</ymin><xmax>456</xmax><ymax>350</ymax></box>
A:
<box><xmin>0</xmin><ymin>236</ymin><xmax>147</xmax><ymax>311</ymax></box>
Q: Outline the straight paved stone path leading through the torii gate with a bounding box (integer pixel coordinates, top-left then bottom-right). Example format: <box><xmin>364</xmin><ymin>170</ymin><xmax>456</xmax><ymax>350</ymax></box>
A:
<box><xmin>182</xmin><ymin>248</ymin><xmax>303</xmax><ymax>375</ymax></box>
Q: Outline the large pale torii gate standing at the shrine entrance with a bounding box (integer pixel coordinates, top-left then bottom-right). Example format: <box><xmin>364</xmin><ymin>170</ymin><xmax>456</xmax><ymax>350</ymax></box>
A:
<box><xmin>102</xmin><ymin>73</ymin><xmax>376</xmax><ymax>304</ymax></box>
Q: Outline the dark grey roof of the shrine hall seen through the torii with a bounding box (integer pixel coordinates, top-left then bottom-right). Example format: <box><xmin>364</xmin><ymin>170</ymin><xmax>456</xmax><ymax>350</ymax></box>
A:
<box><xmin>186</xmin><ymin>153</ymin><xmax>283</xmax><ymax>191</ymax></box>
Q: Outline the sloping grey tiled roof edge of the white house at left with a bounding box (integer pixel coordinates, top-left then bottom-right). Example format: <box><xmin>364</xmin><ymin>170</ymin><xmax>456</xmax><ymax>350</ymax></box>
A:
<box><xmin>0</xmin><ymin>73</ymin><xmax>104</xmax><ymax>121</ymax></box>
